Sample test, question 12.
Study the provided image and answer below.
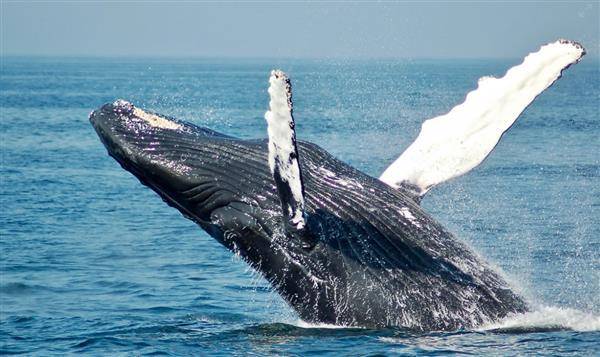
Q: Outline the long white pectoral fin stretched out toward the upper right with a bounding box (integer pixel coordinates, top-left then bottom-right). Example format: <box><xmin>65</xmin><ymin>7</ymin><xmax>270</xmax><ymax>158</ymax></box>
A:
<box><xmin>380</xmin><ymin>40</ymin><xmax>585</xmax><ymax>197</ymax></box>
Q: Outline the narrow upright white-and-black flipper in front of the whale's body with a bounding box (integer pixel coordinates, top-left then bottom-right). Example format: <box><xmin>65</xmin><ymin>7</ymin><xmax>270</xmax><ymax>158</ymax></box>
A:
<box><xmin>265</xmin><ymin>70</ymin><xmax>306</xmax><ymax>243</ymax></box>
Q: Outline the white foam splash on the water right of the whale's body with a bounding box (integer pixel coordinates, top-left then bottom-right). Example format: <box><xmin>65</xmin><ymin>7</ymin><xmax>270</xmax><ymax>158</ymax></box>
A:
<box><xmin>478</xmin><ymin>306</ymin><xmax>600</xmax><ymax>331</ymax></box>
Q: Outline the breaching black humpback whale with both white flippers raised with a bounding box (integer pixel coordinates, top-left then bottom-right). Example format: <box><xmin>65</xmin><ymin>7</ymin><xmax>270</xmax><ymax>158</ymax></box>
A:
<box><xmin>89</xmin><ymin>40</ymin><xmax>585</xmax><ymax>331</ymax></box>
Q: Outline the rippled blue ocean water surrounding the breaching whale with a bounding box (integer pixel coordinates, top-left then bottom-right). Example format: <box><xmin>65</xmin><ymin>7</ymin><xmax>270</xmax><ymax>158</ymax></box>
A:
<box><xmin>0</xmin><ymin>57</ymin><xmax>600</xmax><ymax>356</ymax></box>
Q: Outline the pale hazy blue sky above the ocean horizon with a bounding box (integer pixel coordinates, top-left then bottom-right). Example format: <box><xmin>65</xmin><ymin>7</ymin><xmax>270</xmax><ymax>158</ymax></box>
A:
<box><xmin>0</xmin><ymin>0</ymin><xmax>600</xmax><ymax>58</ymax></box>
